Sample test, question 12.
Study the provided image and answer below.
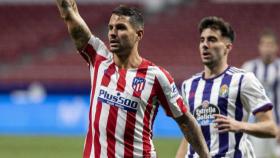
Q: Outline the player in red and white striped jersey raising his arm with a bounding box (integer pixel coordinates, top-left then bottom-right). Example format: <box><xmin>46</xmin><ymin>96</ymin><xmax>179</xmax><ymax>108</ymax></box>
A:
<box><xmin>56</xmin><ymin>0</ymin><xmax>209</xmax><ymax>158</ymax></box>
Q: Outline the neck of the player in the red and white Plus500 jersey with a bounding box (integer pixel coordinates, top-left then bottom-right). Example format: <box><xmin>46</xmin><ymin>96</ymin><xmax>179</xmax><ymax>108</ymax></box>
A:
<box><xmin>113</xmin><ymin>49</ymin><xmax>142</xmax><ymax>69</ymax></box>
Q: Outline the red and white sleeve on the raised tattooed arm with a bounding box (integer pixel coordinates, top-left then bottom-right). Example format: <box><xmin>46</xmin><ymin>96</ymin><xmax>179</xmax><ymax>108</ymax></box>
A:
<box><xmin>79</xmin><ymin>35</ymin><xmax>112</xmax><ymax>63</ymax></box>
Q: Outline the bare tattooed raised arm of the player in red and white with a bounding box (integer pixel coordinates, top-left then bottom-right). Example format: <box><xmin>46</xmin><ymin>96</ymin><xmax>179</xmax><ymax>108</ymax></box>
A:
<box><xmin>56</xmin><ymin>0</ymin><xmax>91</xmax><ymax>49</ymax></box>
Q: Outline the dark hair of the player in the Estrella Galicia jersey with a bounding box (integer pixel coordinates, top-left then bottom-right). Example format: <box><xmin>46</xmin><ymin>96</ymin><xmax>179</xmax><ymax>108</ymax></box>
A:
<box><xmin>199</xmin><ymin>16</ymin><xmax>235</xmax><ymax>42</ymax></box>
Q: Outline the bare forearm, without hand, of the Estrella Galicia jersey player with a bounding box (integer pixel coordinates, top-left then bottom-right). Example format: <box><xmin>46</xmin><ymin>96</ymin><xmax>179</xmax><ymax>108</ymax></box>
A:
<box><xmin>240</xmin><ymin>121</ymin><xmax>277</xmax><ymax>138</ymax></box>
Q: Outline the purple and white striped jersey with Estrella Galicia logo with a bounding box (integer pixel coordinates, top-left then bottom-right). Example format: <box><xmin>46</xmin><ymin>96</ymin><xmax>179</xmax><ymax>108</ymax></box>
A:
<box><xmin>182</xmin><ymin>67</ymin><xmax>272</xmax><ymax>158</ymax></box>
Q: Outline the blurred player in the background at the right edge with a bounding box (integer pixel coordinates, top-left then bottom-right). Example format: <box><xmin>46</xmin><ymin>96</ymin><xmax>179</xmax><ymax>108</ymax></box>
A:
<box><xmin>242</xmin><ymin>30</ymin><xmax>280</xmax><ymax>158</ymax></box>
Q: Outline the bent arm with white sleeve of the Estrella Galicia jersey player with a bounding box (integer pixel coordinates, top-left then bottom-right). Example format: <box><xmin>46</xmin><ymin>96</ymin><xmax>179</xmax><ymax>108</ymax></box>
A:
<box><xmin>215</xmin><ymin>73</ymin><xmax>277</xmax><ymax>138</ymax></box>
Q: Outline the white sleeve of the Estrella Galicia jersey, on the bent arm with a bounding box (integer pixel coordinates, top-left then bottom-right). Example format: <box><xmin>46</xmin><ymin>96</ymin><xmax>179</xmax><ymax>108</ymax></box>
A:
<box><xmin>241</xmin><ymin>72</ymin><xmax>272</xmax><ymax>115</ymax></box>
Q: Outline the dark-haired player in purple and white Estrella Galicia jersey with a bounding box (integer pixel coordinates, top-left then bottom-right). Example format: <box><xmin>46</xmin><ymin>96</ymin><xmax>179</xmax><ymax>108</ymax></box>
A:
<box><xmin>177</xmin><ymin>17</ymin><xmax>277</xmax><ymax>158</ymax></box>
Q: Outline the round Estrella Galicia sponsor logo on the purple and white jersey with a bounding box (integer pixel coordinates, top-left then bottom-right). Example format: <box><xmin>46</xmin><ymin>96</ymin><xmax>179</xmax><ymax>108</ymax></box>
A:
<box><xmin>193</xmin><ymin>100</ymin><xmax>220</xmax><ymax>126</ymax></box>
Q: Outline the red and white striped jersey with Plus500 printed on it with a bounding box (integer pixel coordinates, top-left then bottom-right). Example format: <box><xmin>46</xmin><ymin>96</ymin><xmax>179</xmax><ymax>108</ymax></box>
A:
<box><xmin>80</xmin><ymin>36</ymin><xmax>187</xmax><ymax>158</ymax></box>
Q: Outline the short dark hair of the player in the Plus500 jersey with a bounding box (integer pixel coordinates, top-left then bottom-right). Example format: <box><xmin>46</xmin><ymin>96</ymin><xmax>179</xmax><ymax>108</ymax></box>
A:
<box><xmin>112</xmin><ymin>5</ymin><xmax>144</xmax><ymax>29</ymax></box>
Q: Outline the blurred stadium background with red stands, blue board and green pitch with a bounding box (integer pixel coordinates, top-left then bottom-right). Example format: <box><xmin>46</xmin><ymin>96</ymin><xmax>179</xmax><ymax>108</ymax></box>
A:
<box><xmin>0</xmin><ymin>0</ymin><xmax>280</xmax><ymax>158</ymax></box>
